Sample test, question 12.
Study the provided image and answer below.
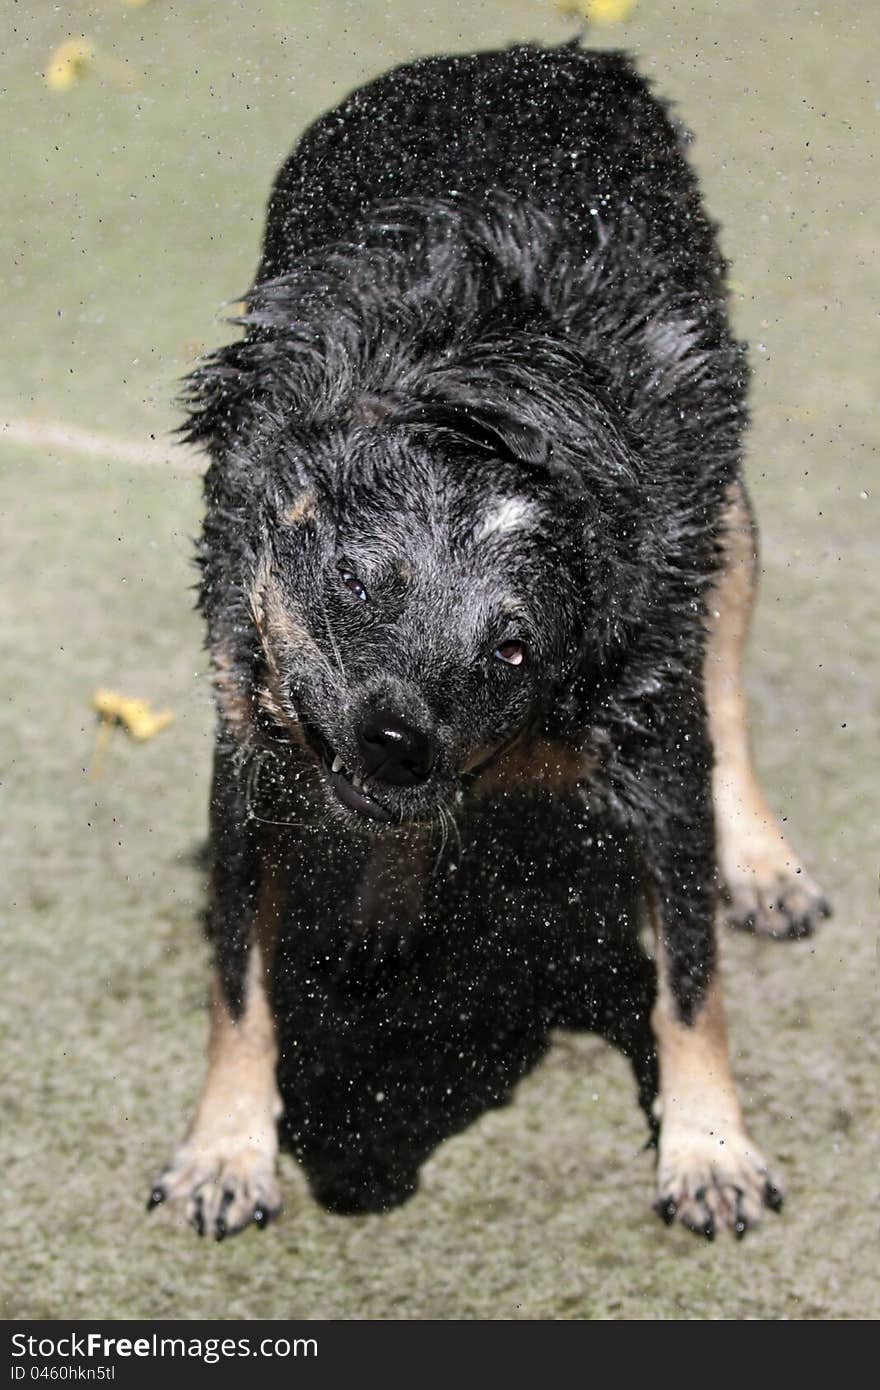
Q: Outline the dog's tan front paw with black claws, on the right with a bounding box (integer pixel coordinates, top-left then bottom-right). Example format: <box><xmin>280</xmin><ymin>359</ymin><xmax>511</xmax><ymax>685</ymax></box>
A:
<box><xmin>655</xmin><ymin>1134</ymin><xmax>784</xmax><ymax>1240</ymax></box>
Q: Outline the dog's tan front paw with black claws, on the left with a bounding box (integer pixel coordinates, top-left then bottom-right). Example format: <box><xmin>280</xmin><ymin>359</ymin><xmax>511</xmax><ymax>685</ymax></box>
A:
<box><xmin>147</xmin><ymin>1143</ymin><xmax>281</xmax><ymax>1240</ymax></box>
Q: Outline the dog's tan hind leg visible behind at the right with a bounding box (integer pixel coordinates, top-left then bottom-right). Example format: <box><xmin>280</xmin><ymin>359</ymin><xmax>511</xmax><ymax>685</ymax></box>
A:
<box><xmin>705</xmin><ymin>482</ymin><xmax>830</xmax><ymax>938</ymax></box>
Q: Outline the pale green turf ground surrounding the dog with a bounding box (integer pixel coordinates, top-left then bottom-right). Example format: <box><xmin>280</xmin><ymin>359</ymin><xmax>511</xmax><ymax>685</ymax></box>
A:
<box><xmin>0</xmin><ymin>0</ymin><xmax>880</xmax><ymax>1318</ymax></box>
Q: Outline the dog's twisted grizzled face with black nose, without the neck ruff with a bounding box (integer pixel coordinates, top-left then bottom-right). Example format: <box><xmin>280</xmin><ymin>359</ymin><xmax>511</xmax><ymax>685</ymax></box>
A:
<box><xmin>250</xmin><ymin>420</ymin><xmax>577</xmax><ymax>823</ymax></box>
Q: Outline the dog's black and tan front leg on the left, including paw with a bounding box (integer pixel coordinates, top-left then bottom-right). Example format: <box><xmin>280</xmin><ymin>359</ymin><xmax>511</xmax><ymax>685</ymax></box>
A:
<box><xmin>149</xmin><ymin>742</ymin><xmax>284</xmax><ymax>1240</ymax></box>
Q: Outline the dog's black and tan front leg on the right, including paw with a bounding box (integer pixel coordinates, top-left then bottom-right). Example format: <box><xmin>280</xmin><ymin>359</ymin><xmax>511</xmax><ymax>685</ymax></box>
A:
<box><xmin>646</xmin><ymin>726</ymin><xmax>781</xmax><ymax>1238</ymax></box>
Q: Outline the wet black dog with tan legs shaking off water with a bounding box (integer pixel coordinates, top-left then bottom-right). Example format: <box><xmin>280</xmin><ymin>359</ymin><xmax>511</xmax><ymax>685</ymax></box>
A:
<box><xmin>147</xmin><ymin>46</ymin><xmax>823</xmax><ymax>1234</ymax></box>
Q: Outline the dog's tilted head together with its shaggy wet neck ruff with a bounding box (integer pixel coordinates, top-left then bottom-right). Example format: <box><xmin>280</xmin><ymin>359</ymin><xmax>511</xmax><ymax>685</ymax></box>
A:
<box><xmin>186</xmin><ymin>195</ymin><xmax>702</xmax><ymax>824</ymax></box>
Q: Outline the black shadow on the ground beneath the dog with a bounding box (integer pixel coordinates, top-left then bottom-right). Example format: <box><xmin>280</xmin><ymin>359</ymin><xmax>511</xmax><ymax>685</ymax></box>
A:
<box><xmin>275</xmin><ymin>798</ymin><xmax>656</xmax><ymax>1212</ymax></box>
